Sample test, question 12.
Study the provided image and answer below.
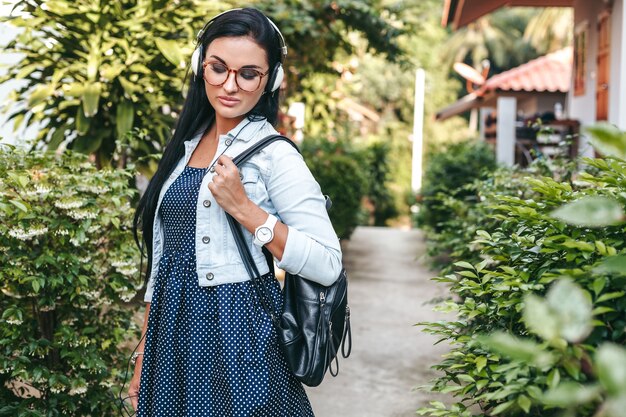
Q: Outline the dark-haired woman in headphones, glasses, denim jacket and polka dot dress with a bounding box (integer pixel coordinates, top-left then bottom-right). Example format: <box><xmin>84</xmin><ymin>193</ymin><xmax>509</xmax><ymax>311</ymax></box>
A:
<box><xmin>129</xmin><ymin>8</ymin><xmax>341</xmax><ymax>417</ymax></box>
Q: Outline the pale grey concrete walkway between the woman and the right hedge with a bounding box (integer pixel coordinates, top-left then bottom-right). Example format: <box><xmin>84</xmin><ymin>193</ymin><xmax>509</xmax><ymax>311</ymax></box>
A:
<box><xmin>307</xmin><ymin>227</ymin><xmax>447</xmax><ymax>417</ymax></box>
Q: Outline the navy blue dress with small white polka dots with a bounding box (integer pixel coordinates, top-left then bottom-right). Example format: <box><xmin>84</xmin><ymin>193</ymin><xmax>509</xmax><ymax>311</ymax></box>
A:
<box><xmin>137</xmin><ymin>166</ymin><xmax>313</xmax><ymax>417</ymax></box>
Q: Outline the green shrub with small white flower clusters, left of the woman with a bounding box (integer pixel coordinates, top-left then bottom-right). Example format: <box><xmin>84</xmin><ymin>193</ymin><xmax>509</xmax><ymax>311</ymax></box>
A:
<box><xmin>0</xmin><ymin>146</ymin><xmax>141</xmax><ymax>416</ymax></box>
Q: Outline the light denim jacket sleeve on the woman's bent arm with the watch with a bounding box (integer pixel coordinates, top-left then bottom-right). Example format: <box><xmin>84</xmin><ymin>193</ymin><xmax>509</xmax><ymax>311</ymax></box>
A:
<box><xmin>267</xmin><ymin>142</ymin><xmax>342</xmax><ymax>286</ymax></box>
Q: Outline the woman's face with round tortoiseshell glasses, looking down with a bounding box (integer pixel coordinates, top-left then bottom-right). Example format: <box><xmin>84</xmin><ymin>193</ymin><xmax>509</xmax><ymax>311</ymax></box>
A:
<box><xmin>203</xmin><ymin>36</ymin><xmax>269</xmax><ymax>120</ymax></box>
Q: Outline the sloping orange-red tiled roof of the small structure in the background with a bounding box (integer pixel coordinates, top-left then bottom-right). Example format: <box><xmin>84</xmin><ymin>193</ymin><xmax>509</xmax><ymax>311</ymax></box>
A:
<box><xmin>477</xmin><ymin>47</ymin><xmax>573</xmax><ymax>95</ymax></box>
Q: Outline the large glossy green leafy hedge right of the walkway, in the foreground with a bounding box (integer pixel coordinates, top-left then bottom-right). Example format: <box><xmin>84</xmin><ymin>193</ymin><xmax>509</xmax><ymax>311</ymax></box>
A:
<box><xmin>419</xmin><ymin>124</ymin><xmax>626</xmax><ymax>417</ymax></box>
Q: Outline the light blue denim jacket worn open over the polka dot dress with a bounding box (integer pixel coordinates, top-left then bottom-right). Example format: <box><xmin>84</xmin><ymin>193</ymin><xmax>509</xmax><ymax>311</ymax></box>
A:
<box><xmin>144</xmin><ymin>115</ymin><xmax>342</xmax><ymax>302</ymax></box>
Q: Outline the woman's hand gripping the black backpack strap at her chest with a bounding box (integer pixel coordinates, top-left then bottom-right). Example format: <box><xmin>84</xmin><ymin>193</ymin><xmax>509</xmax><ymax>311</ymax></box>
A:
<box><xmin>209</xmin><ymin>155</ymin><xmax>251</xmax><ymax>219</ymax></box>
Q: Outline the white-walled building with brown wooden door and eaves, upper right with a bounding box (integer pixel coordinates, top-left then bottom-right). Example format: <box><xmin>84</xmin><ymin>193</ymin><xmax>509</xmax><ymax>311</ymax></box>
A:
<box><xmin>442</xmin><ymin>0</ymin><xmax>626</xmax><ymax>162</ymax></box>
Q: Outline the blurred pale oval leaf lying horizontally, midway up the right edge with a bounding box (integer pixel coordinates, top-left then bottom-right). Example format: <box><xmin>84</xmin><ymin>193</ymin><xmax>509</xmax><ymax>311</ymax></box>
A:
<box><xmin>552</xmin><ymin>196</ymin><xmax>625</xmax><ymax>227</ymax></box>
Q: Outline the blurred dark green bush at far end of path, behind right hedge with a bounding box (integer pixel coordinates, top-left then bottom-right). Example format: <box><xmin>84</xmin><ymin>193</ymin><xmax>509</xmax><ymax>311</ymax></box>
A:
<box><xmin>416</xmin><ymin>141</ymin><xmax>496</xmax><ymax>232</ymax></box>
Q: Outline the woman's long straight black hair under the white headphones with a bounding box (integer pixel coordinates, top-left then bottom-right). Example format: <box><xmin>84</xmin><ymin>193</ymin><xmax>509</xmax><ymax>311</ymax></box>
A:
<box><xmin>133</xmin><ymin>8</ymin><xmax>282</xmax><ymax>283</ymax></box>
